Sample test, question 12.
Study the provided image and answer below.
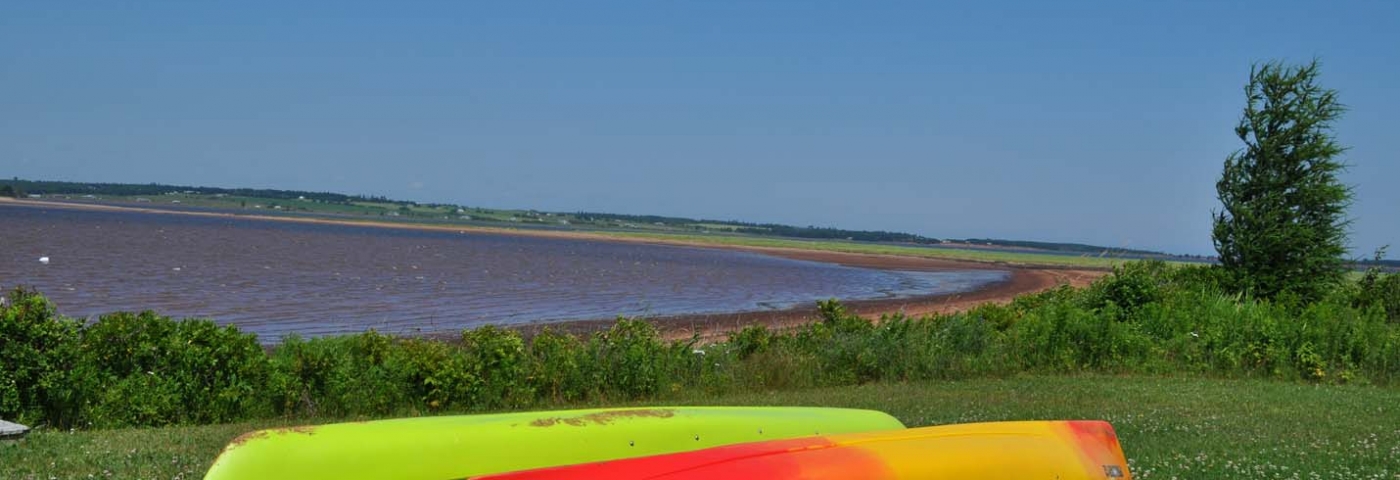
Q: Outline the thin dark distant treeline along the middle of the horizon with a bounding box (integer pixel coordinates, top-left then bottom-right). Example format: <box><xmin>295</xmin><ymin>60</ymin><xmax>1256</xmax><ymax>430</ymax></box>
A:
<box><xmin>575</xmin><ymin>211</ymin><xmax>941</xmax><ymax>243</ymax></box>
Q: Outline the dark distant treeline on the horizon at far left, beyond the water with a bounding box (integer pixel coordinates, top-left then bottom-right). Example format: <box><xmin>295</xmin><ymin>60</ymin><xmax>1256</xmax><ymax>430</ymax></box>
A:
<box><xmin>7</xmin><ymin>179</ymin><xmax>388</xmax><ymax>203</ymax></box>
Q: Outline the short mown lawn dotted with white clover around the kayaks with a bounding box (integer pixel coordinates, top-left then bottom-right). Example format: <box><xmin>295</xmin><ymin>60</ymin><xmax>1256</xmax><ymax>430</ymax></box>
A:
<box><xmin>0</xmin><ymin>375</ymin><xmax>1400</xmax><ymax>480</ymax></box>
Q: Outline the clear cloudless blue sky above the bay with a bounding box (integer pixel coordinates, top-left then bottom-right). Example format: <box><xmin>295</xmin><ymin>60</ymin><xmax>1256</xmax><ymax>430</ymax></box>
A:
<box><xmin>0</xmin><ymin>0</ymin><xmax>1400</xmax><ymax>257</ymax></box>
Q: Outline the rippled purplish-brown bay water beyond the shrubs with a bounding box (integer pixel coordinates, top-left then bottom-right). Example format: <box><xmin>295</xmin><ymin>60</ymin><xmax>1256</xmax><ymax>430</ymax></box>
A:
<box><xmin>0</xmin><ymin>206</ymin><xmax>1007</xmax><ymax>339</ymax></box>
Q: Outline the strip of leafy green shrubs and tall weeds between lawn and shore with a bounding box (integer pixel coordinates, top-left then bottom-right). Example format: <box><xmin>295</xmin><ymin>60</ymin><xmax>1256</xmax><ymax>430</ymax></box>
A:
<box><xmin>0</xmin><ymin>262</ymin><xmax>1400</xmax><ymax>428</ymax></box>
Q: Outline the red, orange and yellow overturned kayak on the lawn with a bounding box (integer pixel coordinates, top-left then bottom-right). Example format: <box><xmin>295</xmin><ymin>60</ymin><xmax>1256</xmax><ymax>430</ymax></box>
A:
<box><xmin>479</xmin><ymin>421</ymin><xmax>1131</xmax><ymax>480</ymax></box>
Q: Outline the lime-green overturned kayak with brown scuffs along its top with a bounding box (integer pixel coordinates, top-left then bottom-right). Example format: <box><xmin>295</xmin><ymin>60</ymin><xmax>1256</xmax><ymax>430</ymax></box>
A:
<box><xmin>204</xmin><ymin>407</ymin><xmax>904</xmax><ymax>480</ymax></box>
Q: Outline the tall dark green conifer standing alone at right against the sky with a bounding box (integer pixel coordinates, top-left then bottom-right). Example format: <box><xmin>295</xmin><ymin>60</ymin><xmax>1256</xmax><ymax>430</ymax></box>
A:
<box><xmin>1211</xmin><ymin>60</ymin><xmax>1352</xmax><ymax>301</ymax></box>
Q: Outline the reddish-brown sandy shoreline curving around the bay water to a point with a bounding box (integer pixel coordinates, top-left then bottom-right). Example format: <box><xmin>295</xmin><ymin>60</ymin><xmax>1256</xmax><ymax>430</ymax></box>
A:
<box><xmin>0</xmin><ymin>197</ymin><xmax>1105</xmax><ymax>339</ymax></box>
